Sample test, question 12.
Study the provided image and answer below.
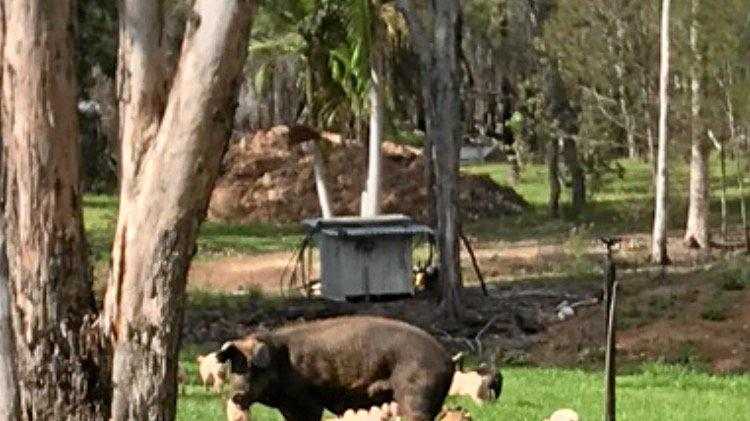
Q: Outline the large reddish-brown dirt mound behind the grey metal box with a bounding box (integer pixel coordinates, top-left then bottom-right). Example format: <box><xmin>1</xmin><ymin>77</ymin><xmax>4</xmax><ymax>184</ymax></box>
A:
<box><xmin>208</xmin><ymin>126</ymin><xmax>528</xmax><ymax>222</ymax></box>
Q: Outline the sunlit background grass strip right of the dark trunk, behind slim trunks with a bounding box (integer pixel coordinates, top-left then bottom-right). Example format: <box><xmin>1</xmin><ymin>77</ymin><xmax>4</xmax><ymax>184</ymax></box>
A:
<box><xmin>462</xmin><ymin>154</ymin><xmax>739</xmax><ymax>242</ymax></box>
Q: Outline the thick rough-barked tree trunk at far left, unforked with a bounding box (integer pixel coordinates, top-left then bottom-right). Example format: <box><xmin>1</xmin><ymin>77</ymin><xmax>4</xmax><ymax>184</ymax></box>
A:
<box><xmin>0</xmin><ymin>0</ymin><xmax>109</xmax><ymax>419</ymax></box>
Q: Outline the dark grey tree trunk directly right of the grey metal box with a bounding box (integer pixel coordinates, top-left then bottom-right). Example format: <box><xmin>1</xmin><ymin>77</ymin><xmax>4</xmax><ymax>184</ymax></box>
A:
<box><xmin>397</xmin><ymin>0</ymin><xmax>463</xmax><ymax>319</ymax></box>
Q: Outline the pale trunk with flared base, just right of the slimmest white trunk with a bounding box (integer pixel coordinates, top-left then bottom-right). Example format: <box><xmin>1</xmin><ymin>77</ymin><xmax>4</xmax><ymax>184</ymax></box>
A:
<box><xmin>685</xmin><ymin>0</ymin><xmax>710</xmax><ymax>248</ymax></box>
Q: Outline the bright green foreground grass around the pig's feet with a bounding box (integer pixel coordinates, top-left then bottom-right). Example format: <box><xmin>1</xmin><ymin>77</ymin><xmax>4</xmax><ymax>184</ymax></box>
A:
<box><xmin>177</xmin><ymin>358</ymin><xmax>750</xmax><ymax>421</ymax></box>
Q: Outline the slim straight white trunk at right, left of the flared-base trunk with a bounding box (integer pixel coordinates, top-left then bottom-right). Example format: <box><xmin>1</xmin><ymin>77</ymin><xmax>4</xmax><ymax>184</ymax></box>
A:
<box><xmin>651</xmin><ymin>0</ymin><xmax>670</xmax><ymax>265</ymax></box>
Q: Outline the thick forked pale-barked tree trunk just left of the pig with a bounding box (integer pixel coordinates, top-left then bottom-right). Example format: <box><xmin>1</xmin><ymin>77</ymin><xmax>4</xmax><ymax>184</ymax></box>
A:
<box><xmin>104</xmin><ymin>0</ymin><xmax>255</xmax><ymax>420</ymax></box>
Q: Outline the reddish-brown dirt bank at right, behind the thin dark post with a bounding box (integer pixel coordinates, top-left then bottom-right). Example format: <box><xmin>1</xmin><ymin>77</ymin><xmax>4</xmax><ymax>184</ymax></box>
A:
<box><xmin>530</xmin><ymin>261</ymin><xmax>750</xmax><ymax>373</ymax></box>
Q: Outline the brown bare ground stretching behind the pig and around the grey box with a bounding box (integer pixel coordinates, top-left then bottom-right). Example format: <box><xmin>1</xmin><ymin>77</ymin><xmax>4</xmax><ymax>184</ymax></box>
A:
<box><xmin>186</xmin><ymin>231</ymin><xmax>750</xmax><ymax>373</ymax></box>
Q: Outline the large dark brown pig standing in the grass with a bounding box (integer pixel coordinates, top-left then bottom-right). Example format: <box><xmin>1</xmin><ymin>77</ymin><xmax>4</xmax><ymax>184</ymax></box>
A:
<box><xmin>217</xmin><ymin>316</ymin><xmax>453</xmax><ymax>421</ymax></box>
